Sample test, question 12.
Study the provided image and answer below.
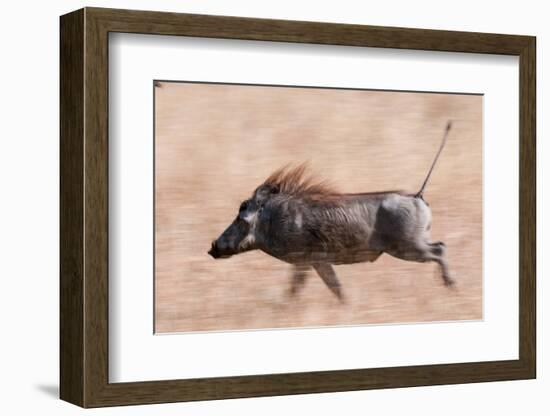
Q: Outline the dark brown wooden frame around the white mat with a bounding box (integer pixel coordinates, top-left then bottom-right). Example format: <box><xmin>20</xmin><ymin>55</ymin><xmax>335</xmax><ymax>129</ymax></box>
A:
<box><xmin>60</xmin><ymin>8</ymin><xmax>536</xmax><ymax>407</ymax></box>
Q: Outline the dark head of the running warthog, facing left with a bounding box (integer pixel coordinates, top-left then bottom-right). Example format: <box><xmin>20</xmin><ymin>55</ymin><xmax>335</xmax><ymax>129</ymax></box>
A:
<box><xmin>208</xmin><ymin>184</ymin><xmax>279</xmax><ymax>259</ymax></box>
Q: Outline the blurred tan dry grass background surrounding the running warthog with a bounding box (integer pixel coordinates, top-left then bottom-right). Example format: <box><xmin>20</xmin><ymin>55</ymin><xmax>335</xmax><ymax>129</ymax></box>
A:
<box><xmin>155</xmin><ymin>82</ymin><xmax>482</xmax><ymax>333</ymax></box>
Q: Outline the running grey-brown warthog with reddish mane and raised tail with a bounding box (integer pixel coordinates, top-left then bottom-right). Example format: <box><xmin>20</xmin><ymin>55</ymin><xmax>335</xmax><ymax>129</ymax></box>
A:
<box><xmin>208</xmin><ymin>123</ymin><xmax>453</xmax><ymax>300</ymax></box>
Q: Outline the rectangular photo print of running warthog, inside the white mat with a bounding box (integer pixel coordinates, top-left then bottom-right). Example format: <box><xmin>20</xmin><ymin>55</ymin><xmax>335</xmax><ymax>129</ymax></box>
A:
<box><xmin>154</xmin><ymin>81</ymin><xmax>483</xmax><ymax>333</ymax></box>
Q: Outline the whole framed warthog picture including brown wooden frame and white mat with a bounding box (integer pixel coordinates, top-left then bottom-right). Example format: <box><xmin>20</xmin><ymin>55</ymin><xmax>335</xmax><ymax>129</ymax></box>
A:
<box><xmin>60</xmin><ymin>8</ymin><xmax>536</xmax><ymax>407</ymax></box>
